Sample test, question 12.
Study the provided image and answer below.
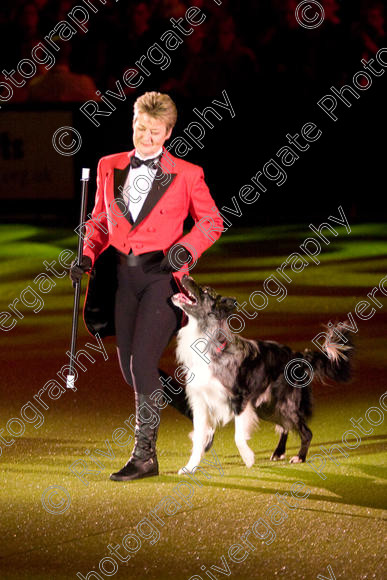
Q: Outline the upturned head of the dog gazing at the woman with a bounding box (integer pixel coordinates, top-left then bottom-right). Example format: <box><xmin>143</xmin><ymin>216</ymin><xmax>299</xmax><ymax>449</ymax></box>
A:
<box><xmin>172</xmin><ymin>276</ymin><xmax>237</xmax><ymax>322</ymax></box>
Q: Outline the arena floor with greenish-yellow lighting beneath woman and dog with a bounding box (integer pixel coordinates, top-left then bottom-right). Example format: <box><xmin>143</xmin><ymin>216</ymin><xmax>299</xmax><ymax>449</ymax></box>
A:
<box><xmin>0</xmin><ymin>224</ymin><xmax>387</xmax><ymax>580</ymax></box>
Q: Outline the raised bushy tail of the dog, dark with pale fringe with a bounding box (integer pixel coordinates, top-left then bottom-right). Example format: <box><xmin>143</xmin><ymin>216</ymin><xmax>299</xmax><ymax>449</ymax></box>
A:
<box><xmin>303</xmin><ymin>322</ymin><xmax>354</xmax><ymax>382</ymax></box>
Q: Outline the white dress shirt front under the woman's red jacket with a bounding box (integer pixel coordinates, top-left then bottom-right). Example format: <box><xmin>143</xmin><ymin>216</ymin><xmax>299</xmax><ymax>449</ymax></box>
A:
<box><xmin>123</xmin><ymin>148</ymin><xmax>163</xmax><ymax>221</ymax></box>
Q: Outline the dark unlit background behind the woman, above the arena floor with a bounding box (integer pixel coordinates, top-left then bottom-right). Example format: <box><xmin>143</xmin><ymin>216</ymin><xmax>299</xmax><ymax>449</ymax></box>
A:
<box><xmin>0</xmin><ymin>0</ymin><xmax>387</xmax><ymax>226</ymax></box>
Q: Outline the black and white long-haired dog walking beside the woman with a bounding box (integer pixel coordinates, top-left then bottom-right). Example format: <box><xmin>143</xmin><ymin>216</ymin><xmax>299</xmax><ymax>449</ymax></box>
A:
<box><xmin>172</xmin><ymin>276</ymin><xmax>353</xmax><ymax>474</ymax></box>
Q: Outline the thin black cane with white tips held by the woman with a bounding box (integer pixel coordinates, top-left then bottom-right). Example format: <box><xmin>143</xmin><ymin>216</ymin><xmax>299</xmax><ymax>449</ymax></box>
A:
<box><xmin>66</xmin><ymin>168</ymin><xmax>90</xmax><ymax>391</ymax></box>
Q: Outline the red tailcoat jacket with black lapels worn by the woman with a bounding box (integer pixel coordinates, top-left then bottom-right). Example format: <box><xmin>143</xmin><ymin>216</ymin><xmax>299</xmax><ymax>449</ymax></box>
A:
<box><xmin>83</xmin><ymin>148</ymin><xmax>223</xmax><ymax>337</ymax></box>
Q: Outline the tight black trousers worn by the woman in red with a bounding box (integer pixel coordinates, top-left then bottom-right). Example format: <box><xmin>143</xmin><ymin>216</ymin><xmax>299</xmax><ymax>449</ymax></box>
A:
<box><xmin>115</xmin><ymin>252</ymin><xmax>187</xmax><ymax>414</ymax></box>
